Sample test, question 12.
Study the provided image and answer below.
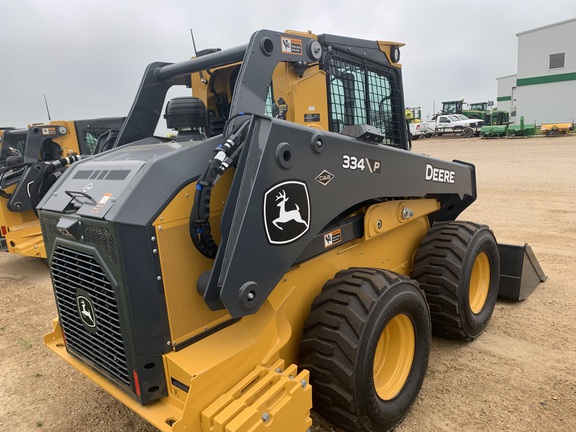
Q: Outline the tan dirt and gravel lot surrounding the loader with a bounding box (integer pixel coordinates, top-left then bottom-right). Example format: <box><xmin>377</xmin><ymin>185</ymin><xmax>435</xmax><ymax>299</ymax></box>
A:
<box><xmin>0</xmin><ymin>136</ymin><xmax>576</xmax><ymax>432</ymax></box>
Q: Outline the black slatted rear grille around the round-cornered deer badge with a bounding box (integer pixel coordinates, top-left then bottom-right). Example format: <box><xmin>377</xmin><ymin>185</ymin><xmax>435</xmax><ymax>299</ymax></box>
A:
<box><xmin>51</xmin><ymin>246</ymin><xmax>131</xmax><ymax>389</ymax></box>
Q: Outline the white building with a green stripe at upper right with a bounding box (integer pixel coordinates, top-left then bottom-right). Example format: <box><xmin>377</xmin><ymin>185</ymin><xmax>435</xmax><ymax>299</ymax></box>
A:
<box><xmin>497</xmin><ymin>18</ymin><xmax>576</xmax><ymax>124</ymax></box>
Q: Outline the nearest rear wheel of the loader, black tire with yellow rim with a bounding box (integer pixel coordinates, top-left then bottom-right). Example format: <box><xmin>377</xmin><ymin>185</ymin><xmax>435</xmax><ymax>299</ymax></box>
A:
<box><xmin>300</xmin><ymin>268</ymin><xmax>431</xmax><ymax>432</ymax></box>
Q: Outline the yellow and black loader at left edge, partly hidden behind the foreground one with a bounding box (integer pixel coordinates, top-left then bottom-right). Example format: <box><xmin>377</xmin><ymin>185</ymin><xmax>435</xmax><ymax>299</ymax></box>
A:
<box><xmin>0</xmin><ymin>117</ymin><xmax>124</xmax><ymax>258</ymax></box>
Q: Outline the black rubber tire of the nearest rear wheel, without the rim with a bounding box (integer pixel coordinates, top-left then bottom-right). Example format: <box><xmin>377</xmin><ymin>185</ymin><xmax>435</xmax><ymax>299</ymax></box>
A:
<box><xmin>300</xmin><ymin>268</ymin><xmax>431</xmax><ymax>432</ymax></box>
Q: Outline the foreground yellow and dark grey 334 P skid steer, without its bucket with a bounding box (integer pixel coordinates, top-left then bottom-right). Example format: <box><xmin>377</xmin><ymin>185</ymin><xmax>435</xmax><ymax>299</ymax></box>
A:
<box><xmin>38</xmin><ymin>30</ymin><xmax>544</xmax><ymax>432</ymax></box>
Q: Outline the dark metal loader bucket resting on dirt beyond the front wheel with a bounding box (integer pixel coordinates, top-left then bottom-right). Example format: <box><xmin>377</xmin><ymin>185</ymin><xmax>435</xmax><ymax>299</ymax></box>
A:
<box><xmin>498</xmin><ymin>243</ymin><xmax>548</xmax><ymax>301</ymax></box>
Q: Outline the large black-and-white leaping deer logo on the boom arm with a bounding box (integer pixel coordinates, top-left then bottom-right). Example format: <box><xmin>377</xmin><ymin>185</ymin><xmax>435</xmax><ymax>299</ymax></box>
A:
<box><xmin>264</xmin><ymin>180</ymin><xmax>310</xmax><ymax>244</ymax></box>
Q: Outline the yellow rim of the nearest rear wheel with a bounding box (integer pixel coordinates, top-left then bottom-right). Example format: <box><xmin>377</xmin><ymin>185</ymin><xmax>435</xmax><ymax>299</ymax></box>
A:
<box><xmin>374</xmin><ymin>314</ymin><xmax>416</xmax><ymax>400</ymax></box>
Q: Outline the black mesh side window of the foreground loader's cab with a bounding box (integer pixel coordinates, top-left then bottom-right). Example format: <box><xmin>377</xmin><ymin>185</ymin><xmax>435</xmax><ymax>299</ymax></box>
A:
<box><xmin>327</xmin><ymin>57</ymin><xmax>403</xmax><ymax>147</ymax></box>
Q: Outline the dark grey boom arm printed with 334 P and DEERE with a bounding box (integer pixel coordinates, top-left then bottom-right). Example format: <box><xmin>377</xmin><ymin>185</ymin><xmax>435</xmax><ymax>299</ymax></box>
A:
<box><xmin>202</xmin><ymin>117</ymin><xmax>476</xmax><ymax>317</ymax></box>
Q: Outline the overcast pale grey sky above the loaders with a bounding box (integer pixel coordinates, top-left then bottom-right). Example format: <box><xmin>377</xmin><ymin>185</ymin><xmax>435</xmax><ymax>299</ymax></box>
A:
<box><xmin>0</xmin><ymin>0</ymin><xmax>576</xmax><ymax>127</ymax></box>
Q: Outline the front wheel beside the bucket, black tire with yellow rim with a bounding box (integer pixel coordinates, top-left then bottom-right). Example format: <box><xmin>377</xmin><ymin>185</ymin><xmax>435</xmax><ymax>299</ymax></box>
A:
<box><xmin>412</xmin><ymin>222</ymin><xmax>500</xmax><ymax>341</ymax></box>
